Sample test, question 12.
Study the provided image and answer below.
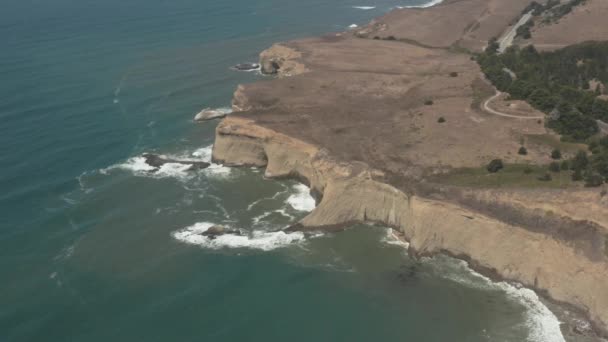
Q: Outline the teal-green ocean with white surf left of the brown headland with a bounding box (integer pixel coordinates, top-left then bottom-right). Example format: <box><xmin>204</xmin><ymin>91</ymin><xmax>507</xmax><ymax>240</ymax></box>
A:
<box><xmin>0</xmin><ymin>0</ymin><xmax>563</xmax><ymax>342</ymax></box>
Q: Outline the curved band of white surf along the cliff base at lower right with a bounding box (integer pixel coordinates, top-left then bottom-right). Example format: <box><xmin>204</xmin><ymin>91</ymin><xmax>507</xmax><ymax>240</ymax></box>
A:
<box><xmin>430</xmin><ymin>260</ymin><xmax>565</xmax><ymax>342</ymax></box>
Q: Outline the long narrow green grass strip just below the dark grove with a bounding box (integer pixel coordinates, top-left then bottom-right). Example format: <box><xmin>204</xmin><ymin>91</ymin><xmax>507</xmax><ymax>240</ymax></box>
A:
<box><xmin>430</xmin><ymin>164</ymin><xmax>582</xmax><ymax>189</ymax></box>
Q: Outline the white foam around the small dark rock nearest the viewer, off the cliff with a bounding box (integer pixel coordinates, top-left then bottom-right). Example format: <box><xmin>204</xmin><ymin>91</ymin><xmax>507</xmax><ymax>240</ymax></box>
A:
<box><xmin>173</xmin><ymin>222</ymin><xmax>305</xmax><ymax>251</ymax></box>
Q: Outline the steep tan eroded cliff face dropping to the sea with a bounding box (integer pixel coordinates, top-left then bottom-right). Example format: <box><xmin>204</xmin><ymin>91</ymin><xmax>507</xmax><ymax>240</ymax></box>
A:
<box><xmin>213</xmin><ymin>116</ymin><xmax>608</xmax><ymax>334</ymax></box>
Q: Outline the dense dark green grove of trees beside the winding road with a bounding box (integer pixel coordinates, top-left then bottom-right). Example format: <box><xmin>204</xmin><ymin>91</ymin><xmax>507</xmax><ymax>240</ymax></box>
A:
<box><xmin>477</xmin><ymin>42</ymin><xmax>608</xmax><ymax>141</ymax></box>
